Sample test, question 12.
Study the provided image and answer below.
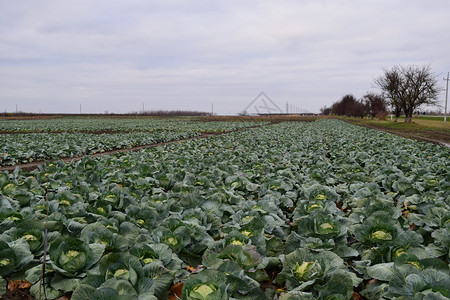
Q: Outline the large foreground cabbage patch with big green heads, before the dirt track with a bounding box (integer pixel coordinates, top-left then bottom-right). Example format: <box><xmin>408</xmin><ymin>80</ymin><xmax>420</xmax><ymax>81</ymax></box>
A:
<box><xmin>0</xmin><ymin>120</ymin><xmax>450</xmax><ymax>300</ymax></box>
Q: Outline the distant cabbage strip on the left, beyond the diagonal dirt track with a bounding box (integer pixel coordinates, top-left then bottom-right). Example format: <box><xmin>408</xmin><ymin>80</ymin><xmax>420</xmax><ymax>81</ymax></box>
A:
<box><xmin>0</xmin><ymin>119</ymin><xmax>264</xmax><ymax>166</ymax></box>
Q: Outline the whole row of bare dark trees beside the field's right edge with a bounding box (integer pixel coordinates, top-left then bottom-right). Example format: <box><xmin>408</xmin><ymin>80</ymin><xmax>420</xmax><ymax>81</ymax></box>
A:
<box><xmin>321</xmin><ymin>65</ymin><xmax>443</xmax><ymax>122</ymax></box>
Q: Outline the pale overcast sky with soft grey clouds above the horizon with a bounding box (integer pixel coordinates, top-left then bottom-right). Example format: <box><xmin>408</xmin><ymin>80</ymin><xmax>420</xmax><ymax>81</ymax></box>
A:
<box><xmin>0</xmin><ymin>0</ymin><xmax>450</xmax><ymax>114</ymax></box>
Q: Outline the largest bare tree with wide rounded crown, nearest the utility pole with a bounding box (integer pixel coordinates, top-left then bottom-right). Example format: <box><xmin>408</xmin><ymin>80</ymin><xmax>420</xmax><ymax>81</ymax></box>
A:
<box><xmin>375</xmin><ymin>65</ymin><xmax>442</xmax><ymax>122</ymax></box>
